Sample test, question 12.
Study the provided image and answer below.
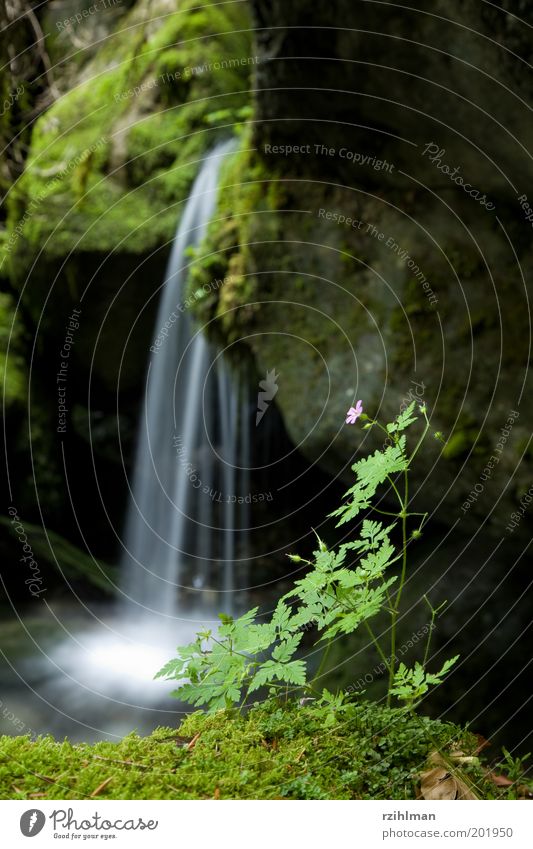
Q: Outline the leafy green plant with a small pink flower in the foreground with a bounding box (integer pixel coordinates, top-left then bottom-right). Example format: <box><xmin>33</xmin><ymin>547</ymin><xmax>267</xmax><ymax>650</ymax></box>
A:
<box><xmin>156</xmin><ymin>401</ymin><xmax>457</xmax><ymax>712</ymax></box>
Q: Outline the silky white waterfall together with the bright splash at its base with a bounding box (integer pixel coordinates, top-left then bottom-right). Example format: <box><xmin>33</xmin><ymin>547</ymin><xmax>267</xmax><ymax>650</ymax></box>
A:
<box><xmin>13</xmin><ymin>143</ymin><xmax>253</xmax><ymax>739</ymax></box>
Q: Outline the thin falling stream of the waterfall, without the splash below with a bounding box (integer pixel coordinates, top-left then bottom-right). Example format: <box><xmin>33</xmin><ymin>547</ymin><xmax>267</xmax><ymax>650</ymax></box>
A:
<box><xmin>121</xmin><ymin>142</ymin><xmax>250</xmax><ymax>616</ymax></box>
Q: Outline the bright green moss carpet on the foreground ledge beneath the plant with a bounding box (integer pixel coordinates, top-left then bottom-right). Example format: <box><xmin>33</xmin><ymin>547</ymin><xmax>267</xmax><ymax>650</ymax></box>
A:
<box><xmin>0</xmin><ymin>703</ymin><xmax>508</xmax><ymax>799</ymax></box>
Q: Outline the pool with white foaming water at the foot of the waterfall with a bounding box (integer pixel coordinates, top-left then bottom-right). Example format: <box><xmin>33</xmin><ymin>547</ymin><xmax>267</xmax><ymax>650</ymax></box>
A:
<box><xmin>0</xmin><ymin>603</ymin><xmax>217</xmax><ymax>741</ymax></box>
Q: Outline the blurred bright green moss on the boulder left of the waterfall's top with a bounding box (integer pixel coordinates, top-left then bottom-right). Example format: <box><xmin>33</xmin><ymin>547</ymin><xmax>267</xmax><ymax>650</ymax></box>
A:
<box><xmin>5</xmin><ymin>0</ymin><xmax>253</xmax><ymax>279</ymax></box>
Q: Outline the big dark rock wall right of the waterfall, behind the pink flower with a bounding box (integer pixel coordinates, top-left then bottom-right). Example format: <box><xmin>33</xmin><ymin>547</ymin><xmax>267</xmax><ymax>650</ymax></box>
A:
<box><xmin>225</xmin><ymin>0</ymin><xmax>533</xmax><ymax>534</ymax></box>
